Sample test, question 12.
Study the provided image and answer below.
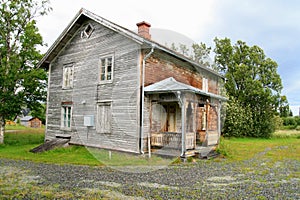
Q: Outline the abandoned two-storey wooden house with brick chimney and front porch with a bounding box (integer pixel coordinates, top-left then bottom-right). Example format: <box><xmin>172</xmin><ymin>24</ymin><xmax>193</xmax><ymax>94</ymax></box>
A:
<box><xmin>38</xmin><ymin>9</ymin><xmax>225</xmax><ymax>157</ymax></box>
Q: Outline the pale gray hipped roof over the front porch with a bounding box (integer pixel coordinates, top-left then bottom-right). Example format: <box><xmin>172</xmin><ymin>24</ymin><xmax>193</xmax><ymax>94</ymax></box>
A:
<box><xmin>144</xmin><ymin>77</ymin><xmax>228</xmax><ymax>101</ymax></box>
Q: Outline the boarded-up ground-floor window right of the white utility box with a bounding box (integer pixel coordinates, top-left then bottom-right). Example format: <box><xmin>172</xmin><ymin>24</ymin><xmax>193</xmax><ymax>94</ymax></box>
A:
<box><xmin>96</xmin><ymin>102</ymin><xmax>111</xmax><ymax>133</ymax></box>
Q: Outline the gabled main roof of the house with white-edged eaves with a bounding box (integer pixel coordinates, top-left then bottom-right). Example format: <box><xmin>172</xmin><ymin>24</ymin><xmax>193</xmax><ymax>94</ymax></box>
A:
<box><xmin>37</xmin><ymin>8</ymin><xmax>223</xmax><ymax>78</ymax></box>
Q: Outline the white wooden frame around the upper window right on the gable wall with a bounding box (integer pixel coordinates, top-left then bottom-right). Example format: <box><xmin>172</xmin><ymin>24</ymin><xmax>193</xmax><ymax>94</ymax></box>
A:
<box><xmin>99</xmin><ymin>54</ymin><xmax>114</xmax><ymax>84</ymax></box>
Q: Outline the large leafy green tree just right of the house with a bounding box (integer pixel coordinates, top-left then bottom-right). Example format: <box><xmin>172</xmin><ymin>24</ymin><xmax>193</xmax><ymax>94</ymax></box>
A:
<box><xmin>214</xmin><ymin>38</ymin><xmax>282</xmax><ymax>137</ymax></box>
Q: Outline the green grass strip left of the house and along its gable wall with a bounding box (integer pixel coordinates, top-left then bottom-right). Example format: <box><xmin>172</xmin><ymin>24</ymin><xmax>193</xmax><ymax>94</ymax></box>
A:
<box><xmin>0</xmin><ymin>130</ymin><xmax>172</xmax><ymax>166</ymax></box>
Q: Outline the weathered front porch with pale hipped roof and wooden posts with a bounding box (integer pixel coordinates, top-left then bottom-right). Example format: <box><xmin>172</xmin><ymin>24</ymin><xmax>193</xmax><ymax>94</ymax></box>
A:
<box><xmin>142</xmin><ymin>78</ymin><xmax>225</xmax><ymax>157</ymax></box>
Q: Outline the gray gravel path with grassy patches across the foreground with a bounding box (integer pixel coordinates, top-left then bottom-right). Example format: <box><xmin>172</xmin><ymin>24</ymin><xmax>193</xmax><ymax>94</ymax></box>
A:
<box><xmin>0</xmin><ymin>158</ymin><xmax>300</xmax><ymax>199</ymax></box>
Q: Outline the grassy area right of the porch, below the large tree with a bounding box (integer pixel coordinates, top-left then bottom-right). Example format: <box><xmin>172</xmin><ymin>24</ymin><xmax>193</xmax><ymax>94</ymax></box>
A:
<box><xmin>219</xmin><ymin>130</ymin><xmax>300</xmax><ymax>161</ymax></box>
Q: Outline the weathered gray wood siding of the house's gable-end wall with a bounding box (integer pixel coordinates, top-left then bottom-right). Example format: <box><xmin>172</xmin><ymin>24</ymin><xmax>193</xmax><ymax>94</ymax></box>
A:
<box><xmin>46</xmin><ymin>20</ymin><xmax>140</xmax><ymax>152</ymax></box>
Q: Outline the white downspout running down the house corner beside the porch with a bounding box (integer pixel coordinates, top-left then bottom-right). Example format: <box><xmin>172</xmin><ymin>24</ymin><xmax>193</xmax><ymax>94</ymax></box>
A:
<box><xmin>140</xmin><ymin>44</ymin><xmax>155</xmax><ymax>157</ymax></box>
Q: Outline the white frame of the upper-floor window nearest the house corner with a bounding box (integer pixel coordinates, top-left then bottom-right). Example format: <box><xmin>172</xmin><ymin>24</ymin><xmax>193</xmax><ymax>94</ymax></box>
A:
<box><xmin>98</xmin><ymin>53</ymin><xmax>115</xmax><ymax>84</ymax></box>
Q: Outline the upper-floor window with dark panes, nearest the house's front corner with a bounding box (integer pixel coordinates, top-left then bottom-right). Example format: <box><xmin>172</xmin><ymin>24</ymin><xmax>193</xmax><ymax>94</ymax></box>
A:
<box><xmin>100</xmin><ymin>56</ymin><xmax>113</xmax><ymax>81</ymax></box>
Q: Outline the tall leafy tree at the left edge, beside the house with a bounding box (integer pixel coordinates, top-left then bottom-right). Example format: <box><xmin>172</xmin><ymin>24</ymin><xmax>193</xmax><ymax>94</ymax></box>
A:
<box><xmin>0</xmin><ymin>0</ymin><xmax>51</xmax><ymax>143</ymax></box>
